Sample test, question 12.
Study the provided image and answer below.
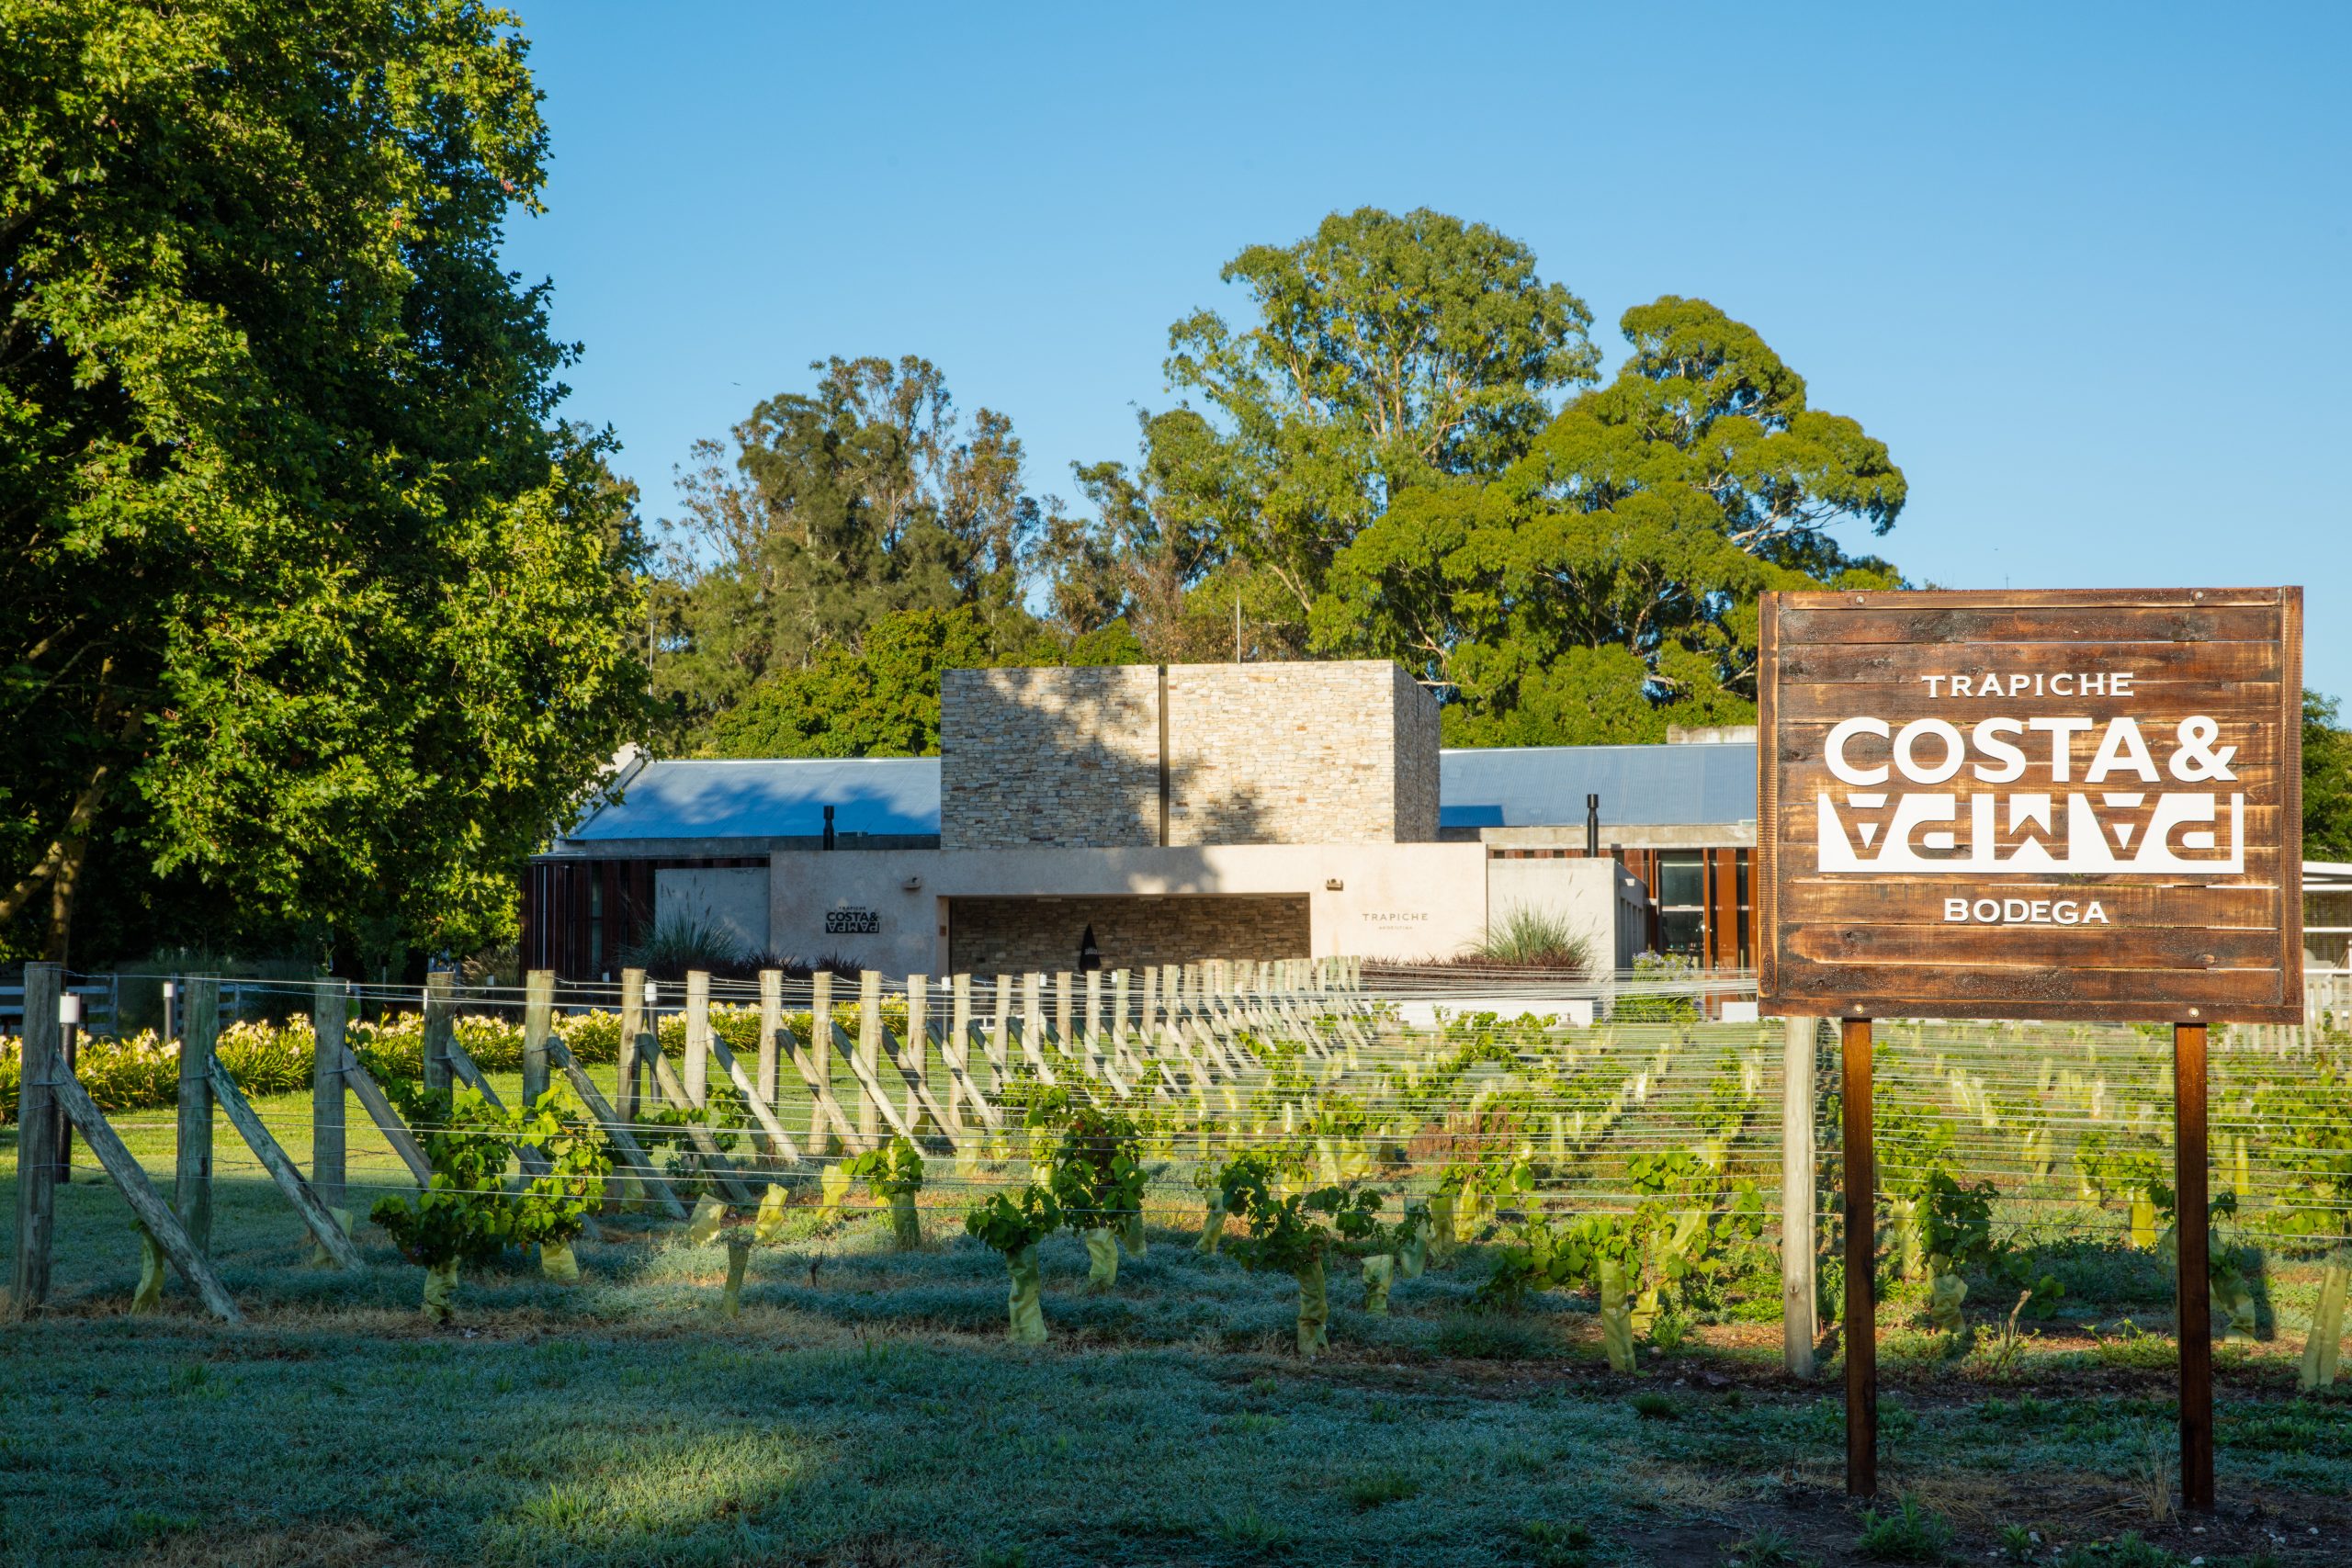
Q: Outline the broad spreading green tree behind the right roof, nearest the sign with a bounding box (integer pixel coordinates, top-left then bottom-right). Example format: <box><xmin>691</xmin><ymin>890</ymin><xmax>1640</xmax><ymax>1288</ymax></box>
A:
<box><xmin>1312</xmin><ymin>296</ymin><xmax>1905</xmax><ymax>745</ymax></box>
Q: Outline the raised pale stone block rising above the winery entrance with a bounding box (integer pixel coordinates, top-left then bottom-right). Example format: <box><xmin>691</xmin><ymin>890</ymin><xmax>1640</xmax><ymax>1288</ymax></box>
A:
<box><xmin>941</xmin><ymin>660</ymin><xmax>1437</xmax><ymax>849</ymax></box>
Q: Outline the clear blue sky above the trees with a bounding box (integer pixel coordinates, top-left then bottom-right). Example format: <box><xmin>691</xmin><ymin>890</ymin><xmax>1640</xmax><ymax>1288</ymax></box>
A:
<box><xmin>508</xmin><ymin>0</ymin><xmax>2352</xmax><ymax>705</ymax></box>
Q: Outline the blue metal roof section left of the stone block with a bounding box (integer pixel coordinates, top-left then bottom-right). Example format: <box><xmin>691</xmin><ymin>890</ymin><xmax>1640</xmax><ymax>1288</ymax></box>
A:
<box><xmin>564</xmin><ymin>757</ymin><xmax>938</xmax><ymax>841</ymax></box>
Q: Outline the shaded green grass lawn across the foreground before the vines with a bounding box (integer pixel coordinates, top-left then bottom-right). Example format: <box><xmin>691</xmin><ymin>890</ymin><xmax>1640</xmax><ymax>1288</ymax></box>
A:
<box><xmin>0</xmin><ymin>1081</ymin><xmax>2352</xmax><ymax>1568</ymax></box>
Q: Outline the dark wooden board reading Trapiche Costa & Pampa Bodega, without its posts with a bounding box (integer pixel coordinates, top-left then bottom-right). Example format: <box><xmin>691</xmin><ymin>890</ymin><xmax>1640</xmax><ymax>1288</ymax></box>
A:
<box><xmin>1757</xmin><ymin>588</ymin><xmax>2302</xmax><ymax>1022</ymax></box>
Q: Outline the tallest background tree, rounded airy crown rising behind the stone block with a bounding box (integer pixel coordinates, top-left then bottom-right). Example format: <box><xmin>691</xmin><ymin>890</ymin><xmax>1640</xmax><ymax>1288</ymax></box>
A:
<box><xmin>1146</xmin><ymin>207</ymin><xmax>1600</xmax><ymax>630</ymax></box>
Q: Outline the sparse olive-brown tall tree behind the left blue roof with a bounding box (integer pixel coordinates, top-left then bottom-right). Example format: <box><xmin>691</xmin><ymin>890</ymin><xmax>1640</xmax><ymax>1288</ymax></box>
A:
<box><xmin>656</xmin><ymin>355</ymin><xmax>1042</xmax><ymax>728</ymax></box>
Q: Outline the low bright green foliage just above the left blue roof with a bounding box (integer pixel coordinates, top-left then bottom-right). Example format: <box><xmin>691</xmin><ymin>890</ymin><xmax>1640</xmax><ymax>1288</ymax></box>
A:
<box><xmin>701</xmin><ymin>604</ymin><xmax>1143</xmax><ymax>757</ymax></box>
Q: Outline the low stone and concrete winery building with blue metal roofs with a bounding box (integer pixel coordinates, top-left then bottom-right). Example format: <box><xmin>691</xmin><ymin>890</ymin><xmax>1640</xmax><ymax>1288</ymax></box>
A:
<box><xmin>522</xmin><ymin>660</ymin><xmax>1755</xmax><ymax>978</ymax></box>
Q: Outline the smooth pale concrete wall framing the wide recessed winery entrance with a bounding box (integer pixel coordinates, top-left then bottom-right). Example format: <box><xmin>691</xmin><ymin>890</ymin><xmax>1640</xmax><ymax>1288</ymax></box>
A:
<box><xmin>769</xmin><ymin>844</ymin><xmax>1487</xmax><ymax>976</ymax></box>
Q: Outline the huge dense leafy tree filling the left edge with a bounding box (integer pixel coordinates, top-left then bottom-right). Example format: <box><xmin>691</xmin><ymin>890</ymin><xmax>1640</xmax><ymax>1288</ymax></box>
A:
<box><xmin>0</xmin><ymin>0</ymin><xmax>644</xmax><ymax>957</ymax></box>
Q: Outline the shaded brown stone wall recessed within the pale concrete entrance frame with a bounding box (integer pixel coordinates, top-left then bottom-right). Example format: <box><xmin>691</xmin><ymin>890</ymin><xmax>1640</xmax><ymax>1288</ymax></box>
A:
<box><xmin>948</xmin><ymin>894</ymin><xmax>1312</xmax><ymax>976</ymax></box>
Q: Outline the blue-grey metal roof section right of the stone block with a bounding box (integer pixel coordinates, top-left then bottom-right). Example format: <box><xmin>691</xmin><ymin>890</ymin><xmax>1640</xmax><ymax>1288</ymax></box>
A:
<box><xmin>1437</xmin><ymin>740</ymin><xmax>1757</xmax><ymax>828</ymax></box>
